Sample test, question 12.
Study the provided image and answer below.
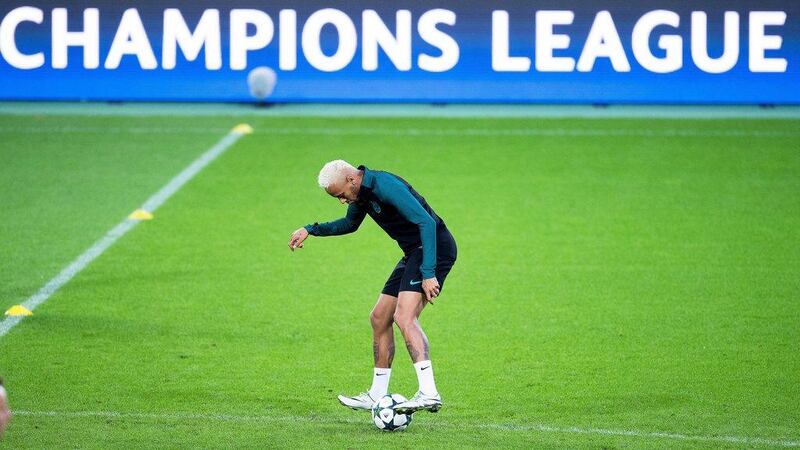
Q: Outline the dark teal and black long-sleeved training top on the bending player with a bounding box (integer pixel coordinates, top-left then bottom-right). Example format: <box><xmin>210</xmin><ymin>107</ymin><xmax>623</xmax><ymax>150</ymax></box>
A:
<box><xmin>305</xmin><ymin>166</ymin><xmax>447</xmax><ymax>279</ymax></box>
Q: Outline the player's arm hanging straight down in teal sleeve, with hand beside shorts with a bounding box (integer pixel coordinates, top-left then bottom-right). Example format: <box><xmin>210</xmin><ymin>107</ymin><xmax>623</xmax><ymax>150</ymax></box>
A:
<box><xmin>374</xmin><ymin>175</ymin><xmax>439</xmax><ymax>303</ymax></box>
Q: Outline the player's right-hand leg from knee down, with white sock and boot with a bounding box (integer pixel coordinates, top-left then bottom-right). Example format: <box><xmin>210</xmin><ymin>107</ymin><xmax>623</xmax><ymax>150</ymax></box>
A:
<box><xmin>394</xmin><ymin>291</ymin><xmax>442</xmax><ymax>414</ymax></box>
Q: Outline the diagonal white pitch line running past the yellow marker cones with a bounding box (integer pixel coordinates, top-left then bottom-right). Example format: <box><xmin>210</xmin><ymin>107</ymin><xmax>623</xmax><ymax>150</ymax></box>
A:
<box><xmin>0</xmin><ymin>127</ymin><xmax>246</xmax><ymax>337</ymax></box>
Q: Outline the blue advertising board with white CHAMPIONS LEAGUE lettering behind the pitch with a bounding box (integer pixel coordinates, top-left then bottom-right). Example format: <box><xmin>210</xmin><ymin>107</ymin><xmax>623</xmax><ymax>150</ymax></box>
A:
<box><xmin>0</xmin><ymin>0</ymin><xmax>800</xmax><ymax>104</ymax></box>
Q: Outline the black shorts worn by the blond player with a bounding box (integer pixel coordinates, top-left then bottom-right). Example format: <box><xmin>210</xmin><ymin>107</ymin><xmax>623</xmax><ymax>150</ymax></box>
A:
<box><xmin>381</xmin><ymin>229</ymin><xmax>458</xmax><ymax>297</ymax></box>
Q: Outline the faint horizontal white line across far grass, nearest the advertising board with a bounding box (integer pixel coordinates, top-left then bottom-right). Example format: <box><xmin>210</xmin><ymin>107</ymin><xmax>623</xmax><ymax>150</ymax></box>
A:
<box><xmin>0</xmin><ymin>126</ymin><xmax>800</xmax><ymax>138</ymax></box>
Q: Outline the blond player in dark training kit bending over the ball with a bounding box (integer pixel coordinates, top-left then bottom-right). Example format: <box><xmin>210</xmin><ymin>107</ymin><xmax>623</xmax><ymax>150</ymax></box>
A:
<box><xmin>289</xmin><ymin>160</ymin><xmax>456</xmax><ymax>414</ymax></box>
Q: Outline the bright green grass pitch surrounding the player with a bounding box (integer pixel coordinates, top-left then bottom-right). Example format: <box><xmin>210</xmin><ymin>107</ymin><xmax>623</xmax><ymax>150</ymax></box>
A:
<box><xmin>0</xmin><ymin>111</ymin><xmax>800</xmax><ymax>449</ymax></box>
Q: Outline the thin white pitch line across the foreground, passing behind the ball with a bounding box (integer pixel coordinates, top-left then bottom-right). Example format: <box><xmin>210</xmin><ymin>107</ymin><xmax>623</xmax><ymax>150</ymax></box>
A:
<box><xmin>14</xmin><ymin>410</ymin><xmax>800</xmax><ymax>447</ymax></box>
